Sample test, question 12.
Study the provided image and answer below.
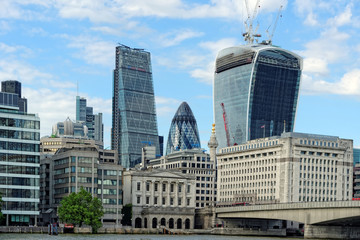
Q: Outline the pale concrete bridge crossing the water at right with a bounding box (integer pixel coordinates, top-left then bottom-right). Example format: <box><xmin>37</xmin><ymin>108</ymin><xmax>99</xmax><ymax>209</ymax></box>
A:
<box><xmin>215</xmin><ymin>201</ymin><xmax>360</xmax><ymax>239</ymax></box>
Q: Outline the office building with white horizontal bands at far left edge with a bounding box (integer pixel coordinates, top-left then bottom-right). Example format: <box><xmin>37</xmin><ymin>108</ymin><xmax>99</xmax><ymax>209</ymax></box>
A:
<box><xmin>0</xmin><ymin>87</ymin><xmax>40</xmax><ymax>226</ymax></box>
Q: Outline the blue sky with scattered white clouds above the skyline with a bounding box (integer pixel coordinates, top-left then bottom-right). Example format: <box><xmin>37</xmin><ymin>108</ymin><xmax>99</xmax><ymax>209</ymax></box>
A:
<box><xmin>0</xmin><ymin>0</ymin><xmax>360</xmax><ymax>148</ymax></box>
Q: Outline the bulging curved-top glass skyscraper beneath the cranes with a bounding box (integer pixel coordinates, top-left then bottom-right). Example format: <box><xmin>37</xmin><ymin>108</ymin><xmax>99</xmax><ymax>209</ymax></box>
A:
<box><xmin>214</xmin><ymin>44</ymin><xmax>302</xmax><ymax>148</ymax></box>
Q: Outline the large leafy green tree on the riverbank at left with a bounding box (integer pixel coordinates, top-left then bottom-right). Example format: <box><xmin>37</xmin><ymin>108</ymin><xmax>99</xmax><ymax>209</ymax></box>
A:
<box><xmin>58</xmin><ymin>188</ymin><xmax>104</xmax><ymax>233</ymax></box>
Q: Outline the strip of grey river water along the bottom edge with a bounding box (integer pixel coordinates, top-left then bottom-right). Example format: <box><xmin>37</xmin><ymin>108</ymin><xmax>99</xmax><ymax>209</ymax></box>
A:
<box><xmin>0</xmin><ymin>233</ymin><xmax>301</xmax><ymax>240</ymax></box>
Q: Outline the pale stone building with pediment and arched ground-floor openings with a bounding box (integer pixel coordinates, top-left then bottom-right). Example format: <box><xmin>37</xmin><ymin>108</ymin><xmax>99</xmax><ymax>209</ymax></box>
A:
<box><xmin>123</xmin><ymin>167</ymin><xmax>195</xmax><ymax>229</ymax></box>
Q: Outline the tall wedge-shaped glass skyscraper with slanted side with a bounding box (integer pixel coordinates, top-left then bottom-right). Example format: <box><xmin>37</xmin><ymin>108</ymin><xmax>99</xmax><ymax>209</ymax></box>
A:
<box><xmin>111</xmin><ymin>45</ymin><xmax>160</xmax><ymax>168</ymax></box>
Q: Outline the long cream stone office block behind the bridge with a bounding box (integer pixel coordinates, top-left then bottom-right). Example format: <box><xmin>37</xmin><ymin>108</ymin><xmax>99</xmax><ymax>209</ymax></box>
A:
<box><xmin>217</xmin><ymin>132</ymin><xmax>353</xmax><ymax>206</ymax></box>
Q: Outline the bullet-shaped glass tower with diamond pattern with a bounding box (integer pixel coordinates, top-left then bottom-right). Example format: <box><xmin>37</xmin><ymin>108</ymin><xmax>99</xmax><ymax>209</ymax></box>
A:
<box><xmin>166</xmin><ymin>102</ymin><xmax>201</xmax><ymax>155</ymax></box>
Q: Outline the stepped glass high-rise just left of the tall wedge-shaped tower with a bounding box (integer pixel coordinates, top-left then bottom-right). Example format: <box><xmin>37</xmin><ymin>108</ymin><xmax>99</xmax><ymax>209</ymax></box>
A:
<box><xmin>76</xmin><ymin>96</ymin><xmax>104</xmax><ymax>142</ymax></box>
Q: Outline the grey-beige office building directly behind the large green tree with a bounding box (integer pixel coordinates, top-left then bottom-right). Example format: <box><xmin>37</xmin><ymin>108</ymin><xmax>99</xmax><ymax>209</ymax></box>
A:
<box><xmin>40</xmin><ymin>140</ymin><xmax>123</xmax><ymax>227</ymax></box>
